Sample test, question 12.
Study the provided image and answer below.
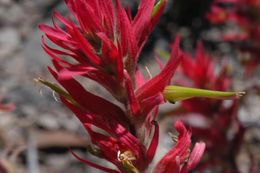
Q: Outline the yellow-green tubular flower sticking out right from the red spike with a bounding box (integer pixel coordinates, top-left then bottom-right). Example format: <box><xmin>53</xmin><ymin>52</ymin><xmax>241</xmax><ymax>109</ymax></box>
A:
<box><xmin>163</xmin><ymin>85</ymin><xmax>245</xmax><ymax>103</ymax></box>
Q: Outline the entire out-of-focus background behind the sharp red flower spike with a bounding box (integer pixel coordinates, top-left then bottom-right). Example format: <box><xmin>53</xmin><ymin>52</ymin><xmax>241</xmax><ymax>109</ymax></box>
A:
<box><xmin>0</xmin><ymin>0</ymin><xmax>260</xmax><ymax>173</ymax></box>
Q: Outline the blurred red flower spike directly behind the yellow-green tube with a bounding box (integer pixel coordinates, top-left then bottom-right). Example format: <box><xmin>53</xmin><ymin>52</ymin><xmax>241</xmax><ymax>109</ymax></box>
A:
<box><xmin>176</xmin><ymin>44</ymin><xmax>245</xmax><ymax>173</ymax></box>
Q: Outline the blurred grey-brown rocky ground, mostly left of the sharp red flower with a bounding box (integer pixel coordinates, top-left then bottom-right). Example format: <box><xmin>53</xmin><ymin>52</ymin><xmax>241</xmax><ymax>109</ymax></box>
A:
<box><xmin>0</xmin><ymin>0</ymin><xmax>260</xmax><ymax>173</ymax></box>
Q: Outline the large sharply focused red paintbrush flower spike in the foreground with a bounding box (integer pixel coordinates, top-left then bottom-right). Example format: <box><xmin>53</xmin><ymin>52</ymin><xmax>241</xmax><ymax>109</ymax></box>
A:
<box><xmin>39</xmin><ymin>0</ymin><xmax>204</xmax><ymax>173</ymax></box>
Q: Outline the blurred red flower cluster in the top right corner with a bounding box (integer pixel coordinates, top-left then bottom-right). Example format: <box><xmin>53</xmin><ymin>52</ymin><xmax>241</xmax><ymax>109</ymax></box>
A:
<box><xmin>208</xmin><ymin>0</ymin><xmax>260</xmax><ymax>71</ymax></box>
